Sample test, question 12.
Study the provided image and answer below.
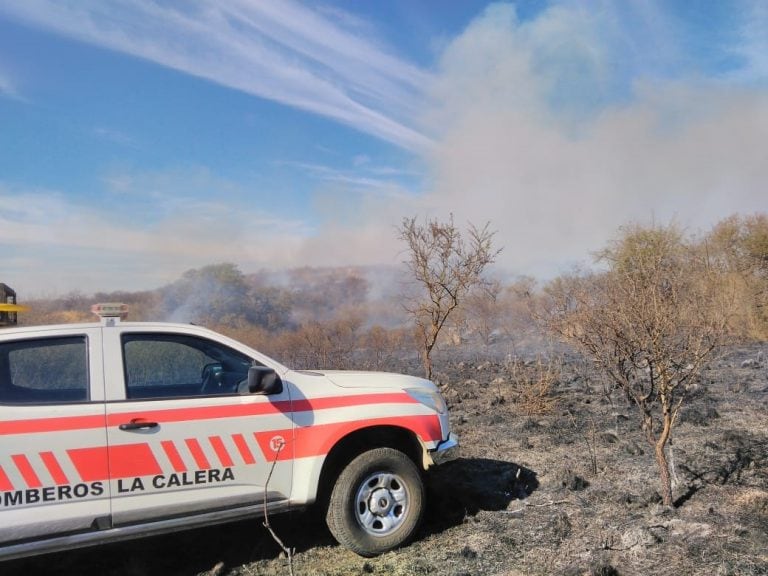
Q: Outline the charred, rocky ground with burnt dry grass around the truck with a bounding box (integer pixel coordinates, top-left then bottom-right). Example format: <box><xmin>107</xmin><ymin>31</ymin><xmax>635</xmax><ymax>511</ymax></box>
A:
<box><xmin>0</xmin><ymin>345</ymin><xmax>768</xmax><ymax>576</ymax></box>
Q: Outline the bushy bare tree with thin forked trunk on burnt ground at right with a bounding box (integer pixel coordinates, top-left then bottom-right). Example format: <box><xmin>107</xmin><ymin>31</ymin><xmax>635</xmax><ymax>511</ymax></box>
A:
<box><xmin>541</xmin><ymin>226</ymin><xmax>733</xmax><ymax>506</ymax></box>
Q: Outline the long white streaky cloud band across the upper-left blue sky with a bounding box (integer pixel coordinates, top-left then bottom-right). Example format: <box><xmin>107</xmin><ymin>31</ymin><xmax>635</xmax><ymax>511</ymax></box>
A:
<box><xmin>0</xmin><ymin>0</ymin><xmax>430</xmax><ymax>150</ymax></box>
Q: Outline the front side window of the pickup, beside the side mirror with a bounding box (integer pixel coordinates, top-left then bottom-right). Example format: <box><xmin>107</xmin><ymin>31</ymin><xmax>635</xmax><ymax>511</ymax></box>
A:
<box><xmin>122</xmin><ymin>333</ymin><xmax>253</xmax><ymax>399</ymax></box>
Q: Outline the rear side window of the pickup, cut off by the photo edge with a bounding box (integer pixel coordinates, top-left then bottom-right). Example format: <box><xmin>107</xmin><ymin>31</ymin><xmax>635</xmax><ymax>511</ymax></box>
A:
<box><xmin>0</xmin><ymin>336</ymin><xmax>89</xmax><ymax>404</ymax></box>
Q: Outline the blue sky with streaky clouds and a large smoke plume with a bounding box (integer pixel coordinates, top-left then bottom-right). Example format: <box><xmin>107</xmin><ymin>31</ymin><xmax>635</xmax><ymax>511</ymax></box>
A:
<box><xmin>0</xmin><ymin>0</ymin><xmax>768</xmax><ymax>301</ymax></box>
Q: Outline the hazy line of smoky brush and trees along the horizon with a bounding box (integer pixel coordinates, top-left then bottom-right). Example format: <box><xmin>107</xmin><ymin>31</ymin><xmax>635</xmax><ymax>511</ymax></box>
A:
<box><xmin>20</xmin><ymin>214</ymin><xmax>768</xmax><ymax>374</ymax></box>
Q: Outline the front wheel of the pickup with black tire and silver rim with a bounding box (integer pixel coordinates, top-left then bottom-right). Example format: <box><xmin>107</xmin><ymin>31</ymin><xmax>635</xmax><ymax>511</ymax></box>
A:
<box><xmin>325</xmin><ymin>448</ymin><xmax>425</xmax><ymax>557</ymax></box>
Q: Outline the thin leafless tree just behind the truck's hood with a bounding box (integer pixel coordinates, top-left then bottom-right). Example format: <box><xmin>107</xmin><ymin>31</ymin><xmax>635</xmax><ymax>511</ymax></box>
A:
<box><xmin>398</xmin><ymin>215</ymin><xmax>500</xmax><ymax>378</ymax></box>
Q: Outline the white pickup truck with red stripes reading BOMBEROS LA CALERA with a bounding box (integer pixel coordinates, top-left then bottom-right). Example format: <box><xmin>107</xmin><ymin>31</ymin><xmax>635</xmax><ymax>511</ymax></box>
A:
<box><xmin>0</xmin><ymin>305</ymin><xmax>458</xmax><ymax>560</ymax></box>
